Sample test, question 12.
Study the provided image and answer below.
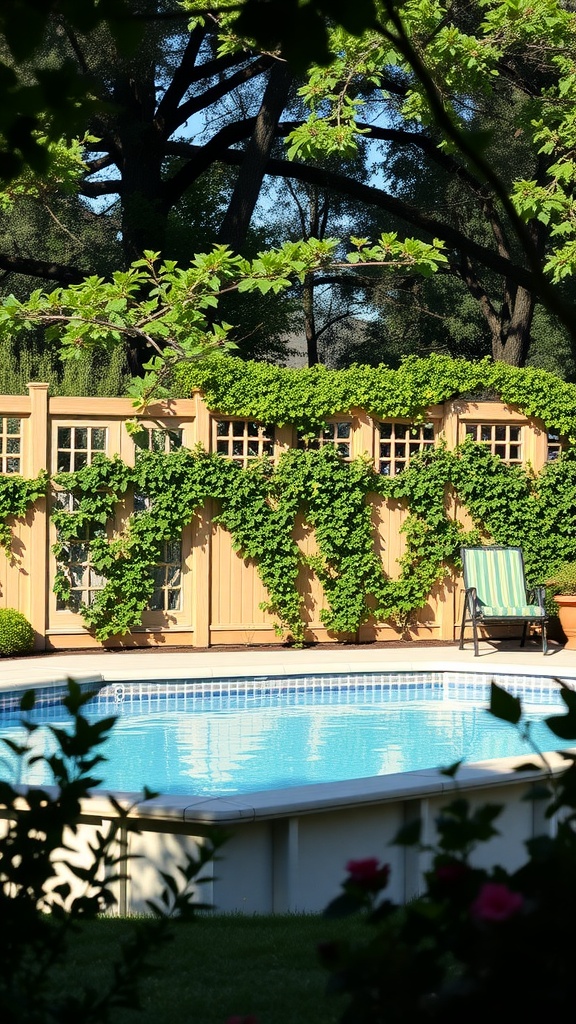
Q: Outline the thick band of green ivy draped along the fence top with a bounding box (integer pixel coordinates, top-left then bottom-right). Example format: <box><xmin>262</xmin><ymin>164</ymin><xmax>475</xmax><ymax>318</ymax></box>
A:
<box><xmin>176</xmin><ymin>354</ymin><xmax>576</xmax><ymax>442</ymax></box>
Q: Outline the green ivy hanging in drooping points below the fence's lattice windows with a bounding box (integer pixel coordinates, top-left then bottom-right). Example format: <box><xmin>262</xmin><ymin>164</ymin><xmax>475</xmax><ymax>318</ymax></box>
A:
<box><xmin>45</xmin><ymin>441</ymin><xmax>576</xmax><ymax>644</ymax></box>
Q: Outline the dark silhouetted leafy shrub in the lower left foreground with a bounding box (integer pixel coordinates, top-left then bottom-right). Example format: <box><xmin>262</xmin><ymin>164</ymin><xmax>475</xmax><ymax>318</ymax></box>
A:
<box><xmin>0</xmin><ymin>679</ymin><xmax>223</xmax><ymax>1024</ymax></box>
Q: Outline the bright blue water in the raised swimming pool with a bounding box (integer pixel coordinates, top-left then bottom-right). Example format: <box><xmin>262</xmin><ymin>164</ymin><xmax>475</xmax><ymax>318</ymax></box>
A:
<box><xmin>0</xmin><ymin>672</ymin><xmax>571</xmax><ymax>797</ymax></box>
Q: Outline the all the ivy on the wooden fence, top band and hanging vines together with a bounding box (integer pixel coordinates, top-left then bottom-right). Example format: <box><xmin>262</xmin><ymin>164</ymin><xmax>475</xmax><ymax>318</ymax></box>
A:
<box><xmin>0</xmin><ymin>356</ymin><xmax>576</xmax><ymax>644</ymax></box>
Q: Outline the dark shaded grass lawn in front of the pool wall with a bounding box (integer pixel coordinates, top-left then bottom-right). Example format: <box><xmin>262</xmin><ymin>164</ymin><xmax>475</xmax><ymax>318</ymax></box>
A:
<box><xmin>50</xmin><ymin>914</ymin><xmax>366</xmax><ymax>1024</ymax></box>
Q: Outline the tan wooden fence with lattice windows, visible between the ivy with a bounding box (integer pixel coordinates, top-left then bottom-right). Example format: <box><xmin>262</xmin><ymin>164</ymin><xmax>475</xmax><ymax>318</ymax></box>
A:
<box><xmin>0</xmin><ymin>383</ymin><xmax>560</xmax><ymax>649</ymax></box>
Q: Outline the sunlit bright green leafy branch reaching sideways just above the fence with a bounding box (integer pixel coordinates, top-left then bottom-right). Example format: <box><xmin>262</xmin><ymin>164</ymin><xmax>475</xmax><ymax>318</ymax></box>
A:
<box><xmin>0</xmin><ymin>233</ymin><xmax>446</xmax><ymax>408</ymax></box>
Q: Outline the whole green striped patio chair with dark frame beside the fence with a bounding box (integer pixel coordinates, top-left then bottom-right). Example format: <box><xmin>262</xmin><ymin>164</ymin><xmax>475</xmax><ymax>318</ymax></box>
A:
<box><xmin>460</xmin><ymin>545</ymin><xmax>548</xmax><ymax>656</ymax></box>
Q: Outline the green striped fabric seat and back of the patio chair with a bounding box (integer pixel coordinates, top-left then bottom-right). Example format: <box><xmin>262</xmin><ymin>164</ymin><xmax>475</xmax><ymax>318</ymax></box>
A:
<box><xmin>463</xmin><ymin>547</ymin><xmax>542</xmax><ymax>617</ymax></box>
